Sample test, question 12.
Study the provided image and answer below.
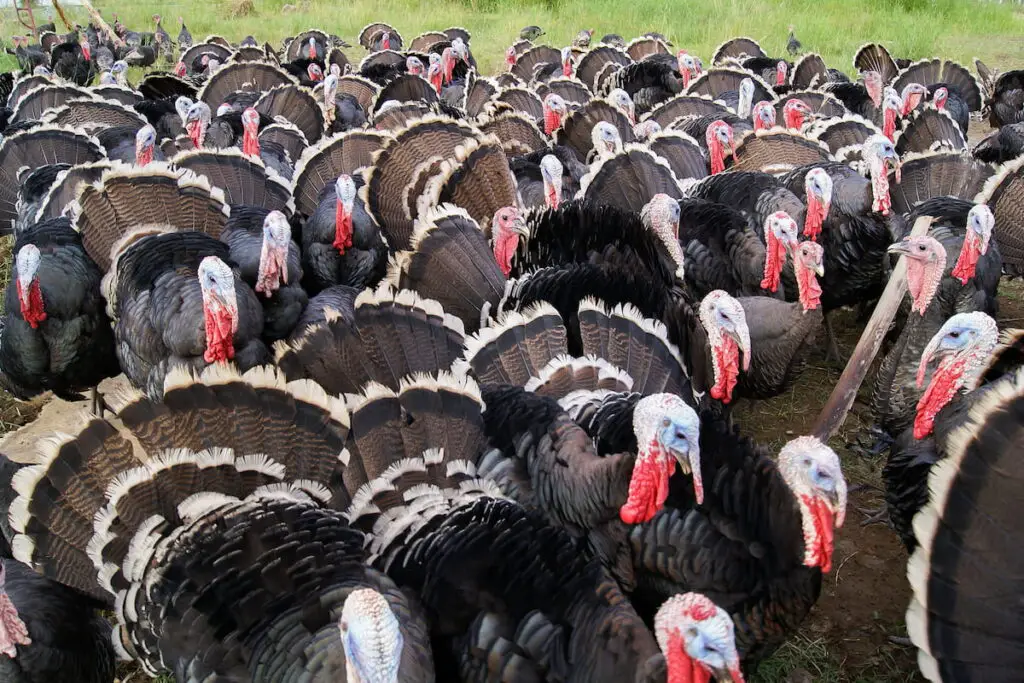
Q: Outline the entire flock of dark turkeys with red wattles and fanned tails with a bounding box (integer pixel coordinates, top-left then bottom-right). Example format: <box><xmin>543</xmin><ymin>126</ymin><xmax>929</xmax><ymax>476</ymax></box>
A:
<box><xmin>0</xmin><ymin>14</ymin><xmax>1024</xmax><ymax>683</ymax></box>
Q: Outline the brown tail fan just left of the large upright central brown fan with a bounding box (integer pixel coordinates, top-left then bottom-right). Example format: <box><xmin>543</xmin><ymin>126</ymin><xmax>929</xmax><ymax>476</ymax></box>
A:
<box><xmin>292</xmin><ymin>130</ymin><xmax>391</xmax><ymax>216</ymax></box>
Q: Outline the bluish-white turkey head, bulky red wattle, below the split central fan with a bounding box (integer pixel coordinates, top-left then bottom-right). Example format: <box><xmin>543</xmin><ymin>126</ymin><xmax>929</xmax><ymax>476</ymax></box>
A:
<box><xmin>618</xmin><ymin>393</ymin><xmax>703</xmax><ymax>524</ymax></box>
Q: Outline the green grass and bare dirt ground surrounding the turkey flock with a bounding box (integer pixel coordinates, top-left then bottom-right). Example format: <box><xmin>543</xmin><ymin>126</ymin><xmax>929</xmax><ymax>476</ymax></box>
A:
<box><xmin>0</xmin><ymin>0</ymin><xmax>1024</xmax><ymax>683</ymax></box>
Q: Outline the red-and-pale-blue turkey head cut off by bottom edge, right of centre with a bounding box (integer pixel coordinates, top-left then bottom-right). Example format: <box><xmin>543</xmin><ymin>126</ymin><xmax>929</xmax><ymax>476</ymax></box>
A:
<box><xmin>654</xmin><ymin>593</ymin><xmax>743</xmax><ymax>683</ymax></box>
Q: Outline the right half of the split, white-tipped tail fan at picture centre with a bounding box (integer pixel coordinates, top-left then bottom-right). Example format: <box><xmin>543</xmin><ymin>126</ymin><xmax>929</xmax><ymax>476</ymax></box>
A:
<box><xmin>580</xmin><ymin>299</ymin><xmax>687</xmax><ymax>394</ymax></box>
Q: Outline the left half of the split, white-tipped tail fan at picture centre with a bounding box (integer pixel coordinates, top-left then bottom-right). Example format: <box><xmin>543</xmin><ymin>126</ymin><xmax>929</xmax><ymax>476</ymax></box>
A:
<box><xmin>457</xmin><ymin>303</ymin><xmax>568</xmax><ymax>386</ymax></box>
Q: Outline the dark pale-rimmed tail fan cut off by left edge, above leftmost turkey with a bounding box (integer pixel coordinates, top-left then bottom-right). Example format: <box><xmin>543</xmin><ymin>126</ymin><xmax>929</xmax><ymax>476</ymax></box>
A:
<box><xmin>0</xmin><ymin>125</ymin><xmax>104</xmax><ymax>234</ymax></box>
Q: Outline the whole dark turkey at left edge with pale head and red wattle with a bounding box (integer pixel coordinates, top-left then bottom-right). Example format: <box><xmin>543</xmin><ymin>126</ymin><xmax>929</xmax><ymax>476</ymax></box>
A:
<box><xmin>0</xmin><ymin>217</ymin><xmax>120</xmax><ymax>400</ymax></box>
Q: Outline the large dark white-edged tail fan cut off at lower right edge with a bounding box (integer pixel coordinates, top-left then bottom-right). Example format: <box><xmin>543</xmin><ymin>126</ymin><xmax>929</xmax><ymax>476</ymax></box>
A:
<box><xmin>906</xmin><ymin>373</ymin><xmax>1024</xmax><ymax>682</ymax></box>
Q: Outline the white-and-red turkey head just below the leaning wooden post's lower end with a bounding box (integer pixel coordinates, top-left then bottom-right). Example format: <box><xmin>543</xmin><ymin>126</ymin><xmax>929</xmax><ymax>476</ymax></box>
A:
<box><xmin>778</xmin><ymin>436</ymin><xmax>846</xmax><ymax>573</ymax></box>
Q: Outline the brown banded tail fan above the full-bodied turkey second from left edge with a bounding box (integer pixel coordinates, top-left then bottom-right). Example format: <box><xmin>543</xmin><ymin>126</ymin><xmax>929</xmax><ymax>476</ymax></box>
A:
<box><xmin>71</xmin><ymin>164</ymin><xmax>229</xmax><ymax>272</ymax></box>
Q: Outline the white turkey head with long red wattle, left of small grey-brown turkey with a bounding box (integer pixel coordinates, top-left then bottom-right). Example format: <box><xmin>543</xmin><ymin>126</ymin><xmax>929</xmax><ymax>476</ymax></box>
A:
<box><xmin>699</xmin><ymin>290</ymin><xmax>751</xmax><ymax>403</ymax></box>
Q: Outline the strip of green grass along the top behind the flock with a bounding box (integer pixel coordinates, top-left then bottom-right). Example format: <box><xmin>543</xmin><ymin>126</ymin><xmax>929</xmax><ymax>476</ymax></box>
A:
<box><xmin>0</xmin><ymin>0</ymin><xmax>1024</xmax><ymax>73</ymax></box>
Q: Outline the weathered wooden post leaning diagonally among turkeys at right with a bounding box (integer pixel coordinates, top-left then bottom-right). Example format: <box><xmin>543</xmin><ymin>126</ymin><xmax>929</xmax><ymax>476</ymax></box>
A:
<box><xmin>813</xmin><ymin>216</ymin><xmax>935</xmax><ymax>441</ymax></box>
